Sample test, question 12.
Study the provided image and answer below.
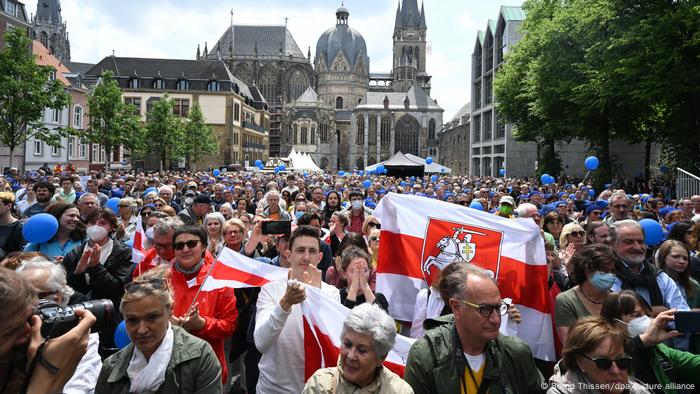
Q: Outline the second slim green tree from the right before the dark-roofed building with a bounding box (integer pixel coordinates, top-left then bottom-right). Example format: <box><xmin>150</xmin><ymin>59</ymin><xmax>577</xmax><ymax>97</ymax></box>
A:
<box><xmin>146</xmin><ymin>94</ymin><xmax>186</xmax><ymax>170</ymax></box>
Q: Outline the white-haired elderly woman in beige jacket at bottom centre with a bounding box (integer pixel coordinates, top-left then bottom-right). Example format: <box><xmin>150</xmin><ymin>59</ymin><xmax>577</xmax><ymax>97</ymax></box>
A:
<box><xmin>303</xmin><ymin>303</ymin><xmax>413</xmax><ymax>394</ymax></box>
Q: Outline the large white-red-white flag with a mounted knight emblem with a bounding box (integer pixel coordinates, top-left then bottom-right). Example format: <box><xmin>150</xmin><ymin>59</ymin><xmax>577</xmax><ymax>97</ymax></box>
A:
<box><xmin>374</xmin><ymin>193</ymin><xmax>555</xmax><ymax>361</ymax></box>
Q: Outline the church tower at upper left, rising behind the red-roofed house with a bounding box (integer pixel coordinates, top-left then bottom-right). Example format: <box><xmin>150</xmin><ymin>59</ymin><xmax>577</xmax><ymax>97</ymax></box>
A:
<box><xmin>32</xmin><ymin>0</ymin><xmax>70</xmax><ymax>64</ymax></box>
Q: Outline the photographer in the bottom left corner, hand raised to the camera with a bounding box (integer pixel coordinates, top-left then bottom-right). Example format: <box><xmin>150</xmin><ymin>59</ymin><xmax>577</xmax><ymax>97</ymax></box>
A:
<box><xmin>0</xmin><ymin>268</ymin><xmax>96</xmax><ymax>394</ymax></box>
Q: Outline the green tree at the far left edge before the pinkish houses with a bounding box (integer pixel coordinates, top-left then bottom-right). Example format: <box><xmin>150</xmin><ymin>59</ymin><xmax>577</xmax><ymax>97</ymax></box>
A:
<box><xmin>0</xmin><ymin>28</ymin><xmax>70</xmax><ymax>166</ymax></box>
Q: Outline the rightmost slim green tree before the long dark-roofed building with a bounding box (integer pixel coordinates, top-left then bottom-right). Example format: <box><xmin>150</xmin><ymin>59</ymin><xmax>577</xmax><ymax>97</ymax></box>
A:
<box><xmin>183</xmin><ymin>103</ymin><xmax>219</xmax><ymax>171</ymax></box>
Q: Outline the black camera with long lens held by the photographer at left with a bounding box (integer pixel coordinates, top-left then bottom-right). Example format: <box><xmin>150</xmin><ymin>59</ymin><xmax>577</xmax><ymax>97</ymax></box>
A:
<box><xmin>33</xmin><ymin>299</ymin><xmax>114</xmax><ymax>339</ymax></box>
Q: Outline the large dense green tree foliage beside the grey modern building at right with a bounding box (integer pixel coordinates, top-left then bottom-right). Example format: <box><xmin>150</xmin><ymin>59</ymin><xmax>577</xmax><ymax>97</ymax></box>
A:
<box><xmin>494</xmin><ymin>0</ymin><xmax>700</xmax><ymax>180</ymax></box>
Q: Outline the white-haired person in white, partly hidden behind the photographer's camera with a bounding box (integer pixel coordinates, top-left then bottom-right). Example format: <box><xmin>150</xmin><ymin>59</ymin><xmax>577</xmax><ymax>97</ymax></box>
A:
<box><xmin>17</xmin><ymin>258</ymin><xmax>102</xmax><ymax>394</ymax></box>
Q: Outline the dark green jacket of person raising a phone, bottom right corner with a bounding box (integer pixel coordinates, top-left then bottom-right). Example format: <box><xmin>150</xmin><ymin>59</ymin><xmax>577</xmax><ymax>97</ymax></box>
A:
<box><xmin>634</xmin><ymin>337</ymin><xmax>700</xmax><ymax>394</ymax></box>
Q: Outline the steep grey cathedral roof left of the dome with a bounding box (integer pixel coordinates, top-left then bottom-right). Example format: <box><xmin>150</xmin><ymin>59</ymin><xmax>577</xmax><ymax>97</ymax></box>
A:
<box><xmin>207</xmin><ymin>25</ymin><xmax>306</xmax><ymax>60</ymax></box>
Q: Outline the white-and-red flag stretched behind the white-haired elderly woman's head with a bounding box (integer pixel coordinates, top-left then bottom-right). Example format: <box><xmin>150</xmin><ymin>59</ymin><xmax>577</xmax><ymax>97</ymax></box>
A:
<box><xmin>301</xmin><ymin>286</ymin><xmax>415</xmax><ymax>381</ymax></box>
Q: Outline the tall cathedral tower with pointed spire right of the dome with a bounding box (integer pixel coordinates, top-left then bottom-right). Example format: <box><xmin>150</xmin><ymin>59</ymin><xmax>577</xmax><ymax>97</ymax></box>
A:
<box><xmin>392</xmin><ymin>0</ymin><xmax>430</xmax><ymax>95</ymax></box>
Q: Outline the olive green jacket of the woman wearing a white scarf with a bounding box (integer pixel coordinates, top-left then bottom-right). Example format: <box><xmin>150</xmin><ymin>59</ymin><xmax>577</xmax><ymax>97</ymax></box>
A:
<box><xmin>95</xmin><ymin>326</ymin><xmax>222</xmax><ymax>394</ymax></box>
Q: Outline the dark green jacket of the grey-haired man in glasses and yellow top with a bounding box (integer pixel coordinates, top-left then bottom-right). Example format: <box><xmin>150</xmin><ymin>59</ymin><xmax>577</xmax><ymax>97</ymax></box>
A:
<box><xmin>404</xmin><ymin>315</ymin><xmax>546</xmax><ymax>394</ymax></box>
